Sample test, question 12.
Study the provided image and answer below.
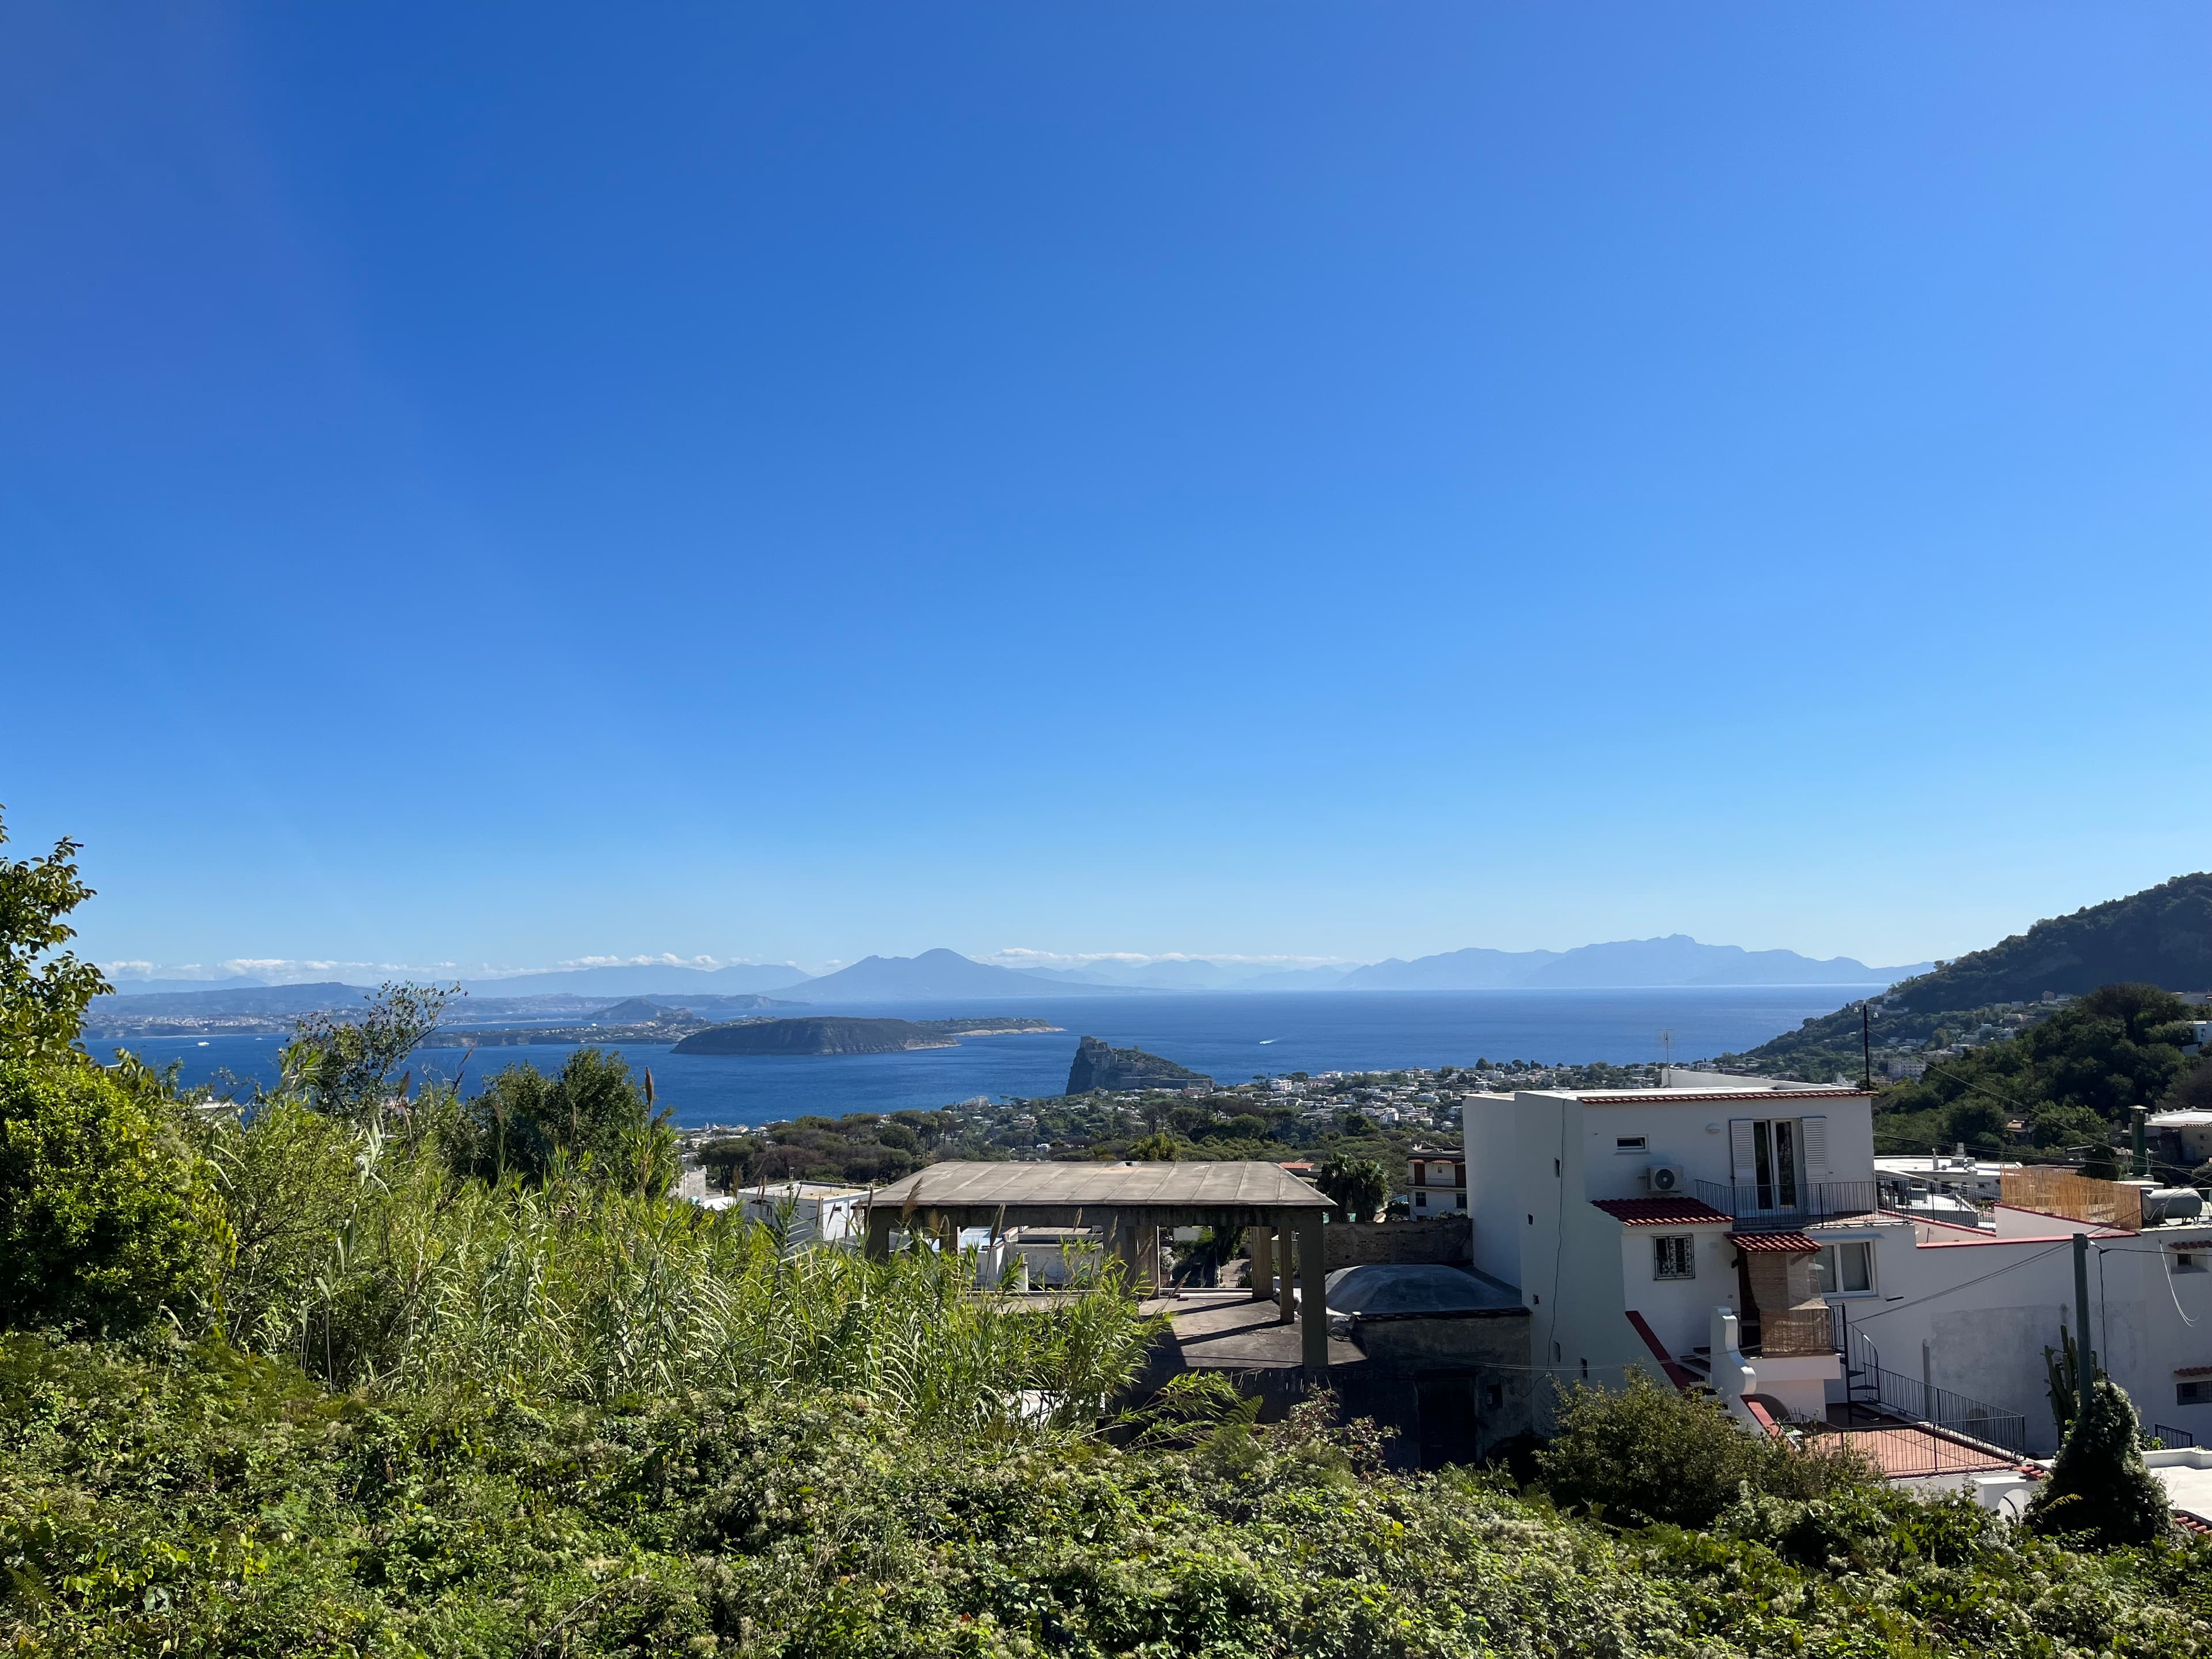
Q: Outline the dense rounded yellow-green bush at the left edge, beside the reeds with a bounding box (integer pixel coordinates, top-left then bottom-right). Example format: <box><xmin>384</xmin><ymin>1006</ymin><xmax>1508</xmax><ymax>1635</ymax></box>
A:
<box><xmin>0</xmin><ymin>1059</ymin><xmax>232</xmax><ymax>1332</ymax></box>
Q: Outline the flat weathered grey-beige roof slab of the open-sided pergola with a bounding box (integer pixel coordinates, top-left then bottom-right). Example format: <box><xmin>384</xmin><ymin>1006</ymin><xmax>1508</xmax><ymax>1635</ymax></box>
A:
<box><xmin>876</xmin><ymin>1164</ymin><xmax>1332</xmax><ymax>1210</ymax></box>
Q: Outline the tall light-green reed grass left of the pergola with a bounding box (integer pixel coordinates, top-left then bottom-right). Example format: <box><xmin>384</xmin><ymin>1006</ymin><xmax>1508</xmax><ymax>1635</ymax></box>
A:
<box><xmin>208</xmin><ymin>1106</ymin><xmax>1153</xmax><ymax>1438</ymax></box>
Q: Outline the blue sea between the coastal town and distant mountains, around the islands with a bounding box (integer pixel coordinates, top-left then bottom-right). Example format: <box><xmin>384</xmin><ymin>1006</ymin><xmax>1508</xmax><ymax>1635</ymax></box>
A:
<box><xmin>108</xmin><ymin>984</ymin><xmax>1878</xmax><ymax>1126</ymax></box>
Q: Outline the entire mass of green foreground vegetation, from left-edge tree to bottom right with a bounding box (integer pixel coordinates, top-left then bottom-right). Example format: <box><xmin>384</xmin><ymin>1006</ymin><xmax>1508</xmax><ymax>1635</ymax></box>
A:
<box><xmin>13</xmin><ymin>814</ymin><xmax>2212</xmax><ymax>1659</ymax></box>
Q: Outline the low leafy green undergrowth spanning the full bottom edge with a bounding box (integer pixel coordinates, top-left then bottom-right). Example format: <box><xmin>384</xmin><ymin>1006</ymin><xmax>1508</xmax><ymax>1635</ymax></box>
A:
<box><xmin>0</xmin><ymin>1336</ymin><xmax>2212</xmax><ymax>1659</ymax></box>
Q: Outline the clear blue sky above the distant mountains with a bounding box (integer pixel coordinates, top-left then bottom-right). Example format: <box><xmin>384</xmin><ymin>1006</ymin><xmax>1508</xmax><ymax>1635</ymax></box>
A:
<box><xmin>0</xmin><ymin>0</ymin><xmax>2212</xmax><ymax>982</ymax></box>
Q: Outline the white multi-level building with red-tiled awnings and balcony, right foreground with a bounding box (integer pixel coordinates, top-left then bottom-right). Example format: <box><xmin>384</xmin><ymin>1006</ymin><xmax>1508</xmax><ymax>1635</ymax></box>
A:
<box><xmin>1467</xmin><ymin>1071</ymin><xmax>2212</xmax><ymax>1456</ymax></box>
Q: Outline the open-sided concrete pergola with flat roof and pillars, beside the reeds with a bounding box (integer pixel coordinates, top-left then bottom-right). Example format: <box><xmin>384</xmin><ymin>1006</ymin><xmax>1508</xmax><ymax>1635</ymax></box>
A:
<box><xmin>867</xmin><ymin>1164</ymin><xmax>1332</xmax><ymax>1376</ymax></box>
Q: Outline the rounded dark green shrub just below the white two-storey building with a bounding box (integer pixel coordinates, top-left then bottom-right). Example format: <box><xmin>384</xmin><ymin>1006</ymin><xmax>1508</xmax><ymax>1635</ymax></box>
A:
<box><xmin>1535</xmin><ymin>1372</ymin><xmax>1873</xmax><ymax>1527</ymax></box>
